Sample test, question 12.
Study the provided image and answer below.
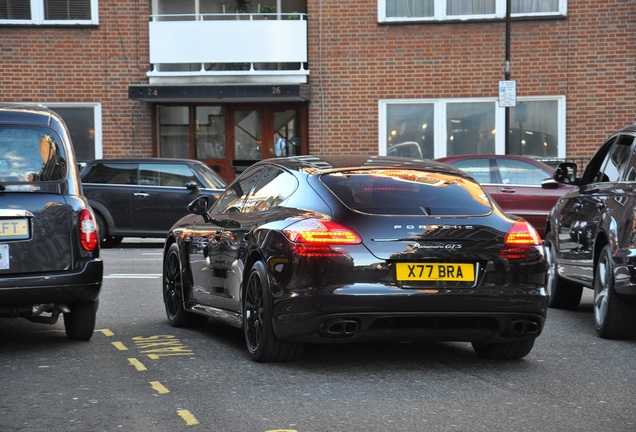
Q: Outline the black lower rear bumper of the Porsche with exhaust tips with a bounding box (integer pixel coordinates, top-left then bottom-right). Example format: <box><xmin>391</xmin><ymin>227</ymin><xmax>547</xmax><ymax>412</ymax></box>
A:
<box><xmin>273</xmin><ymin>286</ymin><xmax>548</xmax><ymax>343</ymax></box>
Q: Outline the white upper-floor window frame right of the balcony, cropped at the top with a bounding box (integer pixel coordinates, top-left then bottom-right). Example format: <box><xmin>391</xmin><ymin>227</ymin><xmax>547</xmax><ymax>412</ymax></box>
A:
<box><xmin>378</xmin><ymin>0</ymin><xmax>568</xmax><ymax>23</ymax></box>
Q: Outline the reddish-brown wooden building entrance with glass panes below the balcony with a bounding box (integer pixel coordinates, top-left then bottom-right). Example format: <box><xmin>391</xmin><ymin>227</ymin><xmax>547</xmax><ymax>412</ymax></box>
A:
<box><xmin>156</xmin><ymin>104</ymin><xmax>308</xmax><ymax>182</ymax></box>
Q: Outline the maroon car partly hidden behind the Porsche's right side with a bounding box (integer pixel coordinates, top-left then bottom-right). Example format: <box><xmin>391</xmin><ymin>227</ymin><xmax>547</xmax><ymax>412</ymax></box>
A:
<box><xmin>437</xmin><ymin>155</ymin><xmax>572</xmax><ymax>238</ymax></box>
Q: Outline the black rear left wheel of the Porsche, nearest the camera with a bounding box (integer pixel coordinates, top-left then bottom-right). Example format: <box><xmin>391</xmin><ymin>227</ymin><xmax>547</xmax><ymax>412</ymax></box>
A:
<box><xmin>243</xmin><ymin>261</ymin><xmax>302</xmax><ymax>362</ymax></box>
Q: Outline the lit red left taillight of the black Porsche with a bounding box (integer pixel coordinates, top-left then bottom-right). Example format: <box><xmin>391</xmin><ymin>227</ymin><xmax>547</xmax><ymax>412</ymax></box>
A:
<box><xmin>283</xmin><ymin>219</ymin><xmax>362</xmax><ymax>256</ymax></box>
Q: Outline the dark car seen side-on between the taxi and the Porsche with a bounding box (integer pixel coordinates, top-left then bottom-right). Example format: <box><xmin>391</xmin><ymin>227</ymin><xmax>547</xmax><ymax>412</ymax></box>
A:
<box><xmin>82</xmin><ymin>158</ymin><xmax>227</xmax><ymax>247</ymax></box>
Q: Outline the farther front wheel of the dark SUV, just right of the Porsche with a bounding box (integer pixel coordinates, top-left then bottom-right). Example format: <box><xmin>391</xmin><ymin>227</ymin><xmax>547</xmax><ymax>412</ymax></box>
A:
<box><xmin>543</xmin><ymin>231</ymin><xmax>583</xmax><ymax>310</ymax></box>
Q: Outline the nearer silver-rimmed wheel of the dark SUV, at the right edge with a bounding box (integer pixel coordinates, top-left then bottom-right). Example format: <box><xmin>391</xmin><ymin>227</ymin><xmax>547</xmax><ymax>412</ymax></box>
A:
<box><xmin>594</xmin><ymin>245</ymin><xmax>636</xmax><ymax>339</ymax></box>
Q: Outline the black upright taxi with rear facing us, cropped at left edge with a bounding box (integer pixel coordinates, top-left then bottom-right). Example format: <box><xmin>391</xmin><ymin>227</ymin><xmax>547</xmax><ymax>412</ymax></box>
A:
<box><xmin>0</xmin><ymin>103</ymin><xmax>103</xmax><ymax>340</ymax></box>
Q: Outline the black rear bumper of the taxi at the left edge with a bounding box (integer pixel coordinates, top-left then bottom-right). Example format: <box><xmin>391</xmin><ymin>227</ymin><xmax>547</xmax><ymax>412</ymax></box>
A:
<box><xmin>0</xmin><ymin>258</ymin><xmax>104</xmax><ymax>310</ymax></box>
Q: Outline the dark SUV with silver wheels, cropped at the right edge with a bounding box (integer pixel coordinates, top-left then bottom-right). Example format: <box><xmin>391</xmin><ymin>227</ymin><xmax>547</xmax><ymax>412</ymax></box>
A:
<box><xmin>545</xmin><ymin>125</ymin><xmax>636</xmax><ymax>339</ymax></box>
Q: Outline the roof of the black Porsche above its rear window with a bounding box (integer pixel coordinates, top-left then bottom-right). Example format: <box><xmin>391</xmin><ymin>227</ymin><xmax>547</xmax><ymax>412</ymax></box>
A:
<box><xmin>255</xmin><ymin>155</ymin><xmax>472</xmax><ymax>178</ymax></box>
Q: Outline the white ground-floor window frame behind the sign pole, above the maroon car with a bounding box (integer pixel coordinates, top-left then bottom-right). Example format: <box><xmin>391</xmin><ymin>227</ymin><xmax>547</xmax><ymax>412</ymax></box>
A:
<box><xmin>378</xmin><ymin>95</ymin><xmax>566</xmax><ymax>159</ymax></box>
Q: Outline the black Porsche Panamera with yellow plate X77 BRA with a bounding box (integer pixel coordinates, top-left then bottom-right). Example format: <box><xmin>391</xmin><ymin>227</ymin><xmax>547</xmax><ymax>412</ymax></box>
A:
<box><xmin>163</xmin><ymin>156</ymin><xmax>547</xmax><ymax>361</ymax></box>
